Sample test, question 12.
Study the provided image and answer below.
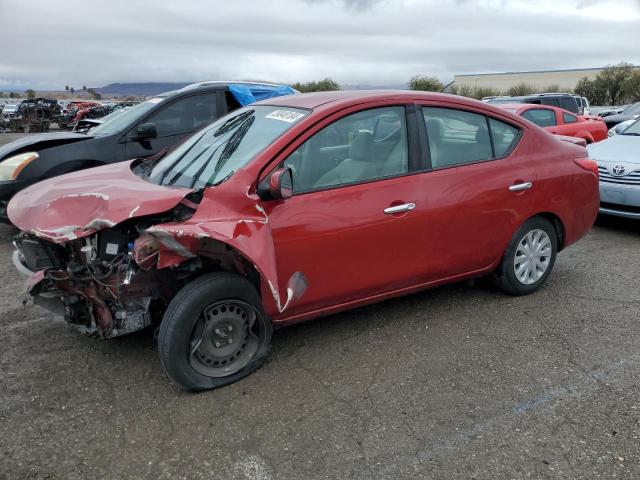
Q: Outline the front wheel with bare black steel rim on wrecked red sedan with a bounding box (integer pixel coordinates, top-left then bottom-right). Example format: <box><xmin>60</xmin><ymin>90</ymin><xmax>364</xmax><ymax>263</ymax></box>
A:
<box><xmin>158</xmin><ymin>272</ymin><xmax>273</xmax><ymax>391</ymax></box>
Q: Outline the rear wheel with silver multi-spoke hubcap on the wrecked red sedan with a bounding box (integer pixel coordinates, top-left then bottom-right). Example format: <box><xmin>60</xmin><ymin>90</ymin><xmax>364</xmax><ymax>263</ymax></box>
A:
<box><xmin>494</xmin><ymin>217</ymin><xmax>558</xmax><ymax>295</ymax></box>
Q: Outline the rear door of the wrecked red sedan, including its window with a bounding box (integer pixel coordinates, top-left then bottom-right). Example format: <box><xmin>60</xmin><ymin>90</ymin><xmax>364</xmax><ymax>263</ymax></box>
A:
<box><xmin>418</xmin><ymin>103</ymin><xmax>536</xmax><ymax>280</ymax></box>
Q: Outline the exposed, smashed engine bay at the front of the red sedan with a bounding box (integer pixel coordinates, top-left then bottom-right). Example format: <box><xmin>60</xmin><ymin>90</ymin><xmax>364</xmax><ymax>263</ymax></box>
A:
<box><xmin>14</xmin><ymin>205</ymin><xmax>258</xmax><ymax>338</ymax></box>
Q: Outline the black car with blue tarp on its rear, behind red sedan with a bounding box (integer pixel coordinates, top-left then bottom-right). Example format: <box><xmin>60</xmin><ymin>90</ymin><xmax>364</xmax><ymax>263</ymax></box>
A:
<box><xmin>0</xmin><ymin>82</ymin><xmax>295</xmax><ymax>221</ymax></box>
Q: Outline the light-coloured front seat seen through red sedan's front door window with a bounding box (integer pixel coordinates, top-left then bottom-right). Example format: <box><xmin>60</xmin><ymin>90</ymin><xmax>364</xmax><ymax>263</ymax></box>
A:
<box><xmin>313</xmin><ymin>131</ymin><xmax>377</xmax><ymax>188</ymax></box>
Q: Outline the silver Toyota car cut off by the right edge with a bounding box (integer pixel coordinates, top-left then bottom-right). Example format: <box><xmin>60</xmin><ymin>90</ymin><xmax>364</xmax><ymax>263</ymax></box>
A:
<box><xmin>587</xmin><ymin>120</ymin><xmax>640</xmax><ymax>219</ymax></box>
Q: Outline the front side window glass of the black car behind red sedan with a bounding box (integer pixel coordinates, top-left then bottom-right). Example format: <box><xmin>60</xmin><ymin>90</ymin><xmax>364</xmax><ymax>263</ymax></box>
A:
<box><xmin>145</xmin><ymin>92</ymin><xmax>218</xmax><ymax>137</ymax></box>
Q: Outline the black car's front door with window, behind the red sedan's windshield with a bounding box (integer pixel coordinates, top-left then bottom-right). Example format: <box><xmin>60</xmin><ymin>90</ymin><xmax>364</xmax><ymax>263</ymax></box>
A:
<box><xmin>125</xmin><ymin>91</ymin><xmax>224</xmax><ymax>158</ymax></box>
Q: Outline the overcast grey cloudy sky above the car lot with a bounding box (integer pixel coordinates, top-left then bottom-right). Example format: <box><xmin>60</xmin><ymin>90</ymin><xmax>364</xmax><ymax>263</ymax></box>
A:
<box><xmin>0</xmin><ymin>0</ymin><xmax>640</xmax><ymax>90</ymax></box>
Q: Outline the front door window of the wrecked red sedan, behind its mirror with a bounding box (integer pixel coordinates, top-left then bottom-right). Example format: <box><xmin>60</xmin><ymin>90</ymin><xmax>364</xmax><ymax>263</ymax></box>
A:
<box><xmin>283</xmin><ymin>107</ymin><xmax>409</xmax><ymax>193</ymax></box>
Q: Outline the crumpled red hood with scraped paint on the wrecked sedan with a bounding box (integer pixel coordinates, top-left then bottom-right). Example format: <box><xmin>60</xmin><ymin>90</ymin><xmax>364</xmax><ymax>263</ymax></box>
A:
<box><xmin>7</xmin><ymin>161</ymin><xmax>192</xmax><ymax>243</ymax></box>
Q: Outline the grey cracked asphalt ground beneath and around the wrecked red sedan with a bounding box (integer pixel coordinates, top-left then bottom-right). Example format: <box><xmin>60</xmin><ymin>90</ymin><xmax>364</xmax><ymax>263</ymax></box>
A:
<box><xmin>0</xmin><ymin>134</ymin><xmax>640</xmax><ymax>480</ymax></box>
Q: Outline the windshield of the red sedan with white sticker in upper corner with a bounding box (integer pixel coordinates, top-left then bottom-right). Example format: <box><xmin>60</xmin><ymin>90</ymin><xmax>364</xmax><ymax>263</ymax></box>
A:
<box><xmin>144</xmin><ymin>105</ymin><xmax>309</xmax><ymax>188</ymax></box>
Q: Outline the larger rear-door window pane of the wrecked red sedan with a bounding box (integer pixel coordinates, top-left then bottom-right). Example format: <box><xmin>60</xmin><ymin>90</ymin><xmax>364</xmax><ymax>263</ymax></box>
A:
<box><xmin>422</xmin><ymin>107</ymin><xmax>493</xmax><ymax>168</ymax></box>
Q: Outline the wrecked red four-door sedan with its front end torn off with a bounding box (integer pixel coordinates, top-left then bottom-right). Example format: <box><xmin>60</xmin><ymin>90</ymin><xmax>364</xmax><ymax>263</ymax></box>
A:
<box><xmin>9</xmin><ymin>91</ymin><xmax>598</xmax><ymax>390</ymax></box>
